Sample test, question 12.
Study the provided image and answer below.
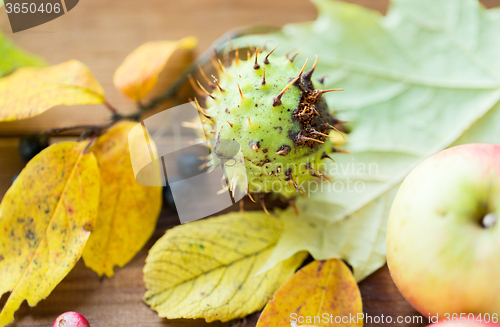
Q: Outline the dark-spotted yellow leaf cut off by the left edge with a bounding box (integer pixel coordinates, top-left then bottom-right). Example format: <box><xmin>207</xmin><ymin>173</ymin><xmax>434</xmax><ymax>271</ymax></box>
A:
<box><xmin>0</xmin><ymin>142</ymin><xmax>99</xmax><ymax>327</ymax></box>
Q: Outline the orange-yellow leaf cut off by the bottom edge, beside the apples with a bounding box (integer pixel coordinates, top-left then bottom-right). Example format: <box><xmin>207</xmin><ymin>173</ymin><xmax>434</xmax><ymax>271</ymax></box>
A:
<box><xmin>257</xmin><ymin>259</ymin><xmax>363</xmax><ymax>327</ymax></box>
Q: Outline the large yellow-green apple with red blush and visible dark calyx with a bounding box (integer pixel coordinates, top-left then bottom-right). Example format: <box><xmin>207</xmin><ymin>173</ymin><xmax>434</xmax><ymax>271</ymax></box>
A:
<box><xmin>387</xmin><ymin>144</ymin><xmax>500</xmax><ymax>320</ymax></box>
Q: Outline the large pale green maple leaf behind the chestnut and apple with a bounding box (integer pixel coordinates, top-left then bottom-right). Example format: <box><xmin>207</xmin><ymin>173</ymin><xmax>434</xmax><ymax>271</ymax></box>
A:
<box><xmin>236</xmin><ymin>0</ymin><xmax>500</xmax><ymax>280</ymax></box>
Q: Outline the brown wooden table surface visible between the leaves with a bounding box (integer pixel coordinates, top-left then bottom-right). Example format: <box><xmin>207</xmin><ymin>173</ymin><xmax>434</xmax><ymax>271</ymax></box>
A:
<box><xmin>0</xmin><ymin>0</ymin><xmax>500</xmax><ymax>327</ymax></box>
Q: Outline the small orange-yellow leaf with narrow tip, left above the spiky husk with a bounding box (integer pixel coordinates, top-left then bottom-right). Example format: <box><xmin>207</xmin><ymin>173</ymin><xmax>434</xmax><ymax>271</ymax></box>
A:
<box><xmin>113</xmin><ymin>37</ymin><xmax>198</xmax><ymax>101</ymax></box>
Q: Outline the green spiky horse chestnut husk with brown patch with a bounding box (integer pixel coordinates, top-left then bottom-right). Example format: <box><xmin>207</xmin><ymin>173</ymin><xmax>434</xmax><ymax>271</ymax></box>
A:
<box><xmin>193</xmin><ymin>45</ymin><xmax>342</xmax><ymax>210</ymax></box>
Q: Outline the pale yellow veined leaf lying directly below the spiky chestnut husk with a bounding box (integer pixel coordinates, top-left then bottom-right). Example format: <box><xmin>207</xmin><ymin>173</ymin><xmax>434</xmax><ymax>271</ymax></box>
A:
<box><xmin>144</xmin><ymin>211</ymin><xmax>306</xmax><ymax>322</ymax></box>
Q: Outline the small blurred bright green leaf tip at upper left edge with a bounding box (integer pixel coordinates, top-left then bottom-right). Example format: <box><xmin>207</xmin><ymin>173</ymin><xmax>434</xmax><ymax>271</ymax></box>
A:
<box><xmin>0</xmin><ymin>30</ymin><xmax>47</xmax><ymax>77</ymax></box>
